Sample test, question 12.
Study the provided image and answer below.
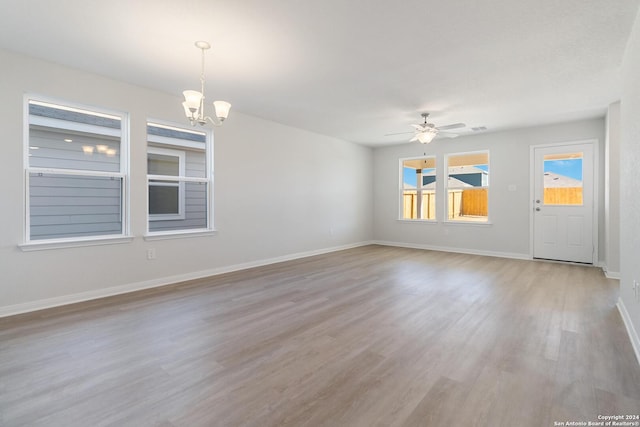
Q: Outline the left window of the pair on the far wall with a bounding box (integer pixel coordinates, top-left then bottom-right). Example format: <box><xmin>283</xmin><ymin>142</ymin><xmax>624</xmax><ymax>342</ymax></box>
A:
<box><xmin>400</xmin><ymin>157</ymin><xmax>436</xmax><ymax>220</ymax></box>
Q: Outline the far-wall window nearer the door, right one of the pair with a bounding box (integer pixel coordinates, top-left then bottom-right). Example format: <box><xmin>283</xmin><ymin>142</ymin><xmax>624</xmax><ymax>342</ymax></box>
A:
<box><xmin>446</xmin><ymin>151</ymin><xmax>489</xmax><ymax>222</ymax></box>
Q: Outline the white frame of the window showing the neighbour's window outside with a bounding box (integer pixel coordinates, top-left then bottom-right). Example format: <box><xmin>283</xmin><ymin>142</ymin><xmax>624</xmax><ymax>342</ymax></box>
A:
<box><xmin>144</xmin><ymin>119</ymin><xmax>216</xmax><ymax>240</ymax></box>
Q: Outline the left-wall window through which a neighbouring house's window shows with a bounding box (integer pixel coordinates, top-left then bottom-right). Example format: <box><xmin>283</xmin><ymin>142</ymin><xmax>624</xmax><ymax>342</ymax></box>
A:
<box><xmin>147</xmin><ymin>123</ymin><xmax>211</xmax><ymax>234</ymax></box>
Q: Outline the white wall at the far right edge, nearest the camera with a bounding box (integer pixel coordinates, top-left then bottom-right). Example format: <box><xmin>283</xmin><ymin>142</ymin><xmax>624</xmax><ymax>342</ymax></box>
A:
<box><xmin>620</xmin><ymin>7</ymin><xmax>640</xmax><ymax>361</ymax></box>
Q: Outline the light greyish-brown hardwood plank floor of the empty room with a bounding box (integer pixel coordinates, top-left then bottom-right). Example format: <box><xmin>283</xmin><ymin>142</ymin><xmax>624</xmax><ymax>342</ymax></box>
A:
<box><xmin>0</xmin><ymin>246</ymin><xmax>640</xmax><ymax>427</ymax></box>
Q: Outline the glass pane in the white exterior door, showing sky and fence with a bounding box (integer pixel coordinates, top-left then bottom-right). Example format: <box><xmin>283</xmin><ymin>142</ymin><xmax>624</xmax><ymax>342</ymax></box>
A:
<box><xmin>543</xmin><ymin>153</ymin><xmax>582</xmax><ymax>205</ymax></box>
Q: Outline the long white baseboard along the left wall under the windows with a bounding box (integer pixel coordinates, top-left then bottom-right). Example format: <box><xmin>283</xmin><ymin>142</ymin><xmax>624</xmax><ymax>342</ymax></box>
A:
<box><xmin>0</xmin><ymin>241</ymin><xmax>374</xmax><ymax>318</ymax></box>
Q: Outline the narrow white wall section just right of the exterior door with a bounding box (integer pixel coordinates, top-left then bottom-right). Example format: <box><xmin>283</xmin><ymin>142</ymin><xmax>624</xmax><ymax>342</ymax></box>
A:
<box><xmin>604</xmin><ymin>102</ymin><xmax>620</xmax><ymax>278</ymax></box>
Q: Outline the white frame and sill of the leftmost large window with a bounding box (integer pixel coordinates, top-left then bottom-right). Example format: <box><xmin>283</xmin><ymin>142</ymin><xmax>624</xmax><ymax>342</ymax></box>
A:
<box><xmin>19</xmin><ymin>94</ymin><xmax>133</xmax><ymax>251</ymax></box>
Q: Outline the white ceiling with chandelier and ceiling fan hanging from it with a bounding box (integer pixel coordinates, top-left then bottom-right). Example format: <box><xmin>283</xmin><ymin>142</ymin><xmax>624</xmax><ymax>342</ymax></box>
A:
<box><xmin>0</xmin><ymin>0</ymin><xmax>640</xmax><ymax>146</ymax></box>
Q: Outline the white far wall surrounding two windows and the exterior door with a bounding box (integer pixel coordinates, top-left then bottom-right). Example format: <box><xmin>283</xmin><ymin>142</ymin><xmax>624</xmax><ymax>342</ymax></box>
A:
<box><xmin>373</xmin><ymin>119</ymin><xmax>605</xmax><ymax>259</ymax></box>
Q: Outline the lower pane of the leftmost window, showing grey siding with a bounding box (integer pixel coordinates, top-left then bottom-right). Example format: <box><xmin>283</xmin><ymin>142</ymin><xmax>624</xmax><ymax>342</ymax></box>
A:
<box><xmin>29</xmin><ymin>173</ymin><xmax>122</xmax><ymax>240</ymax></box>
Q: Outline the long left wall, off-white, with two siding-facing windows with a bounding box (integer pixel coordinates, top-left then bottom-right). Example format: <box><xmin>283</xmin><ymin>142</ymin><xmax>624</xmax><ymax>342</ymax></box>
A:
<box><xmin>0</xmin><ymin>51</ymin><xmax>372</xmax><ymax>314</ymax></box>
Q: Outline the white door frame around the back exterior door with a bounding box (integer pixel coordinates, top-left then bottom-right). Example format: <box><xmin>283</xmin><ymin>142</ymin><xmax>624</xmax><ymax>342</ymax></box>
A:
<box><xmin>529</xmin><ymin>138</ymin><xmax>600</xmax><ymax>266</ymax></box>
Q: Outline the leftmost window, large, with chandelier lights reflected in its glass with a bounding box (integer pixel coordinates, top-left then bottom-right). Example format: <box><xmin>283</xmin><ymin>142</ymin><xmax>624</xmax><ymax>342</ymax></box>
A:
<box><xmin>25</xmin><ymin>99</ymin><xmax>127</xmax><ymax>243</ymax></box>
